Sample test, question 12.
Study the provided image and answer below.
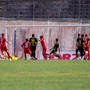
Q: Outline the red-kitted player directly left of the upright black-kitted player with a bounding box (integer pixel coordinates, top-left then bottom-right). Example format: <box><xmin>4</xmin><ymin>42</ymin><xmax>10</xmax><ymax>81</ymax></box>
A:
<box><xmin>21</xmin><ymin>38</ymin><xmax>32</xmax><ymax>59</ymax></box>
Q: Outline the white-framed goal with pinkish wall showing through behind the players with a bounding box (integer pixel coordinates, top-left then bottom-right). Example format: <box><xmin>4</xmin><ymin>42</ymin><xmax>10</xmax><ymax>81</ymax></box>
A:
<box><xmin>5</xmin><ymin>24</ymin><xmax>90</xmax><ymax>57</ymax></box>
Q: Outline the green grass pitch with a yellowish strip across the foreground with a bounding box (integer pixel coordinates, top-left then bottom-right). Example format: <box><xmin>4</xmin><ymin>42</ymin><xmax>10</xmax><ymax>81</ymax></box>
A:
<box><xmin>0</xmin><ymin>60</ymin><xmax>90</xmax><ymax>90</ymax></box>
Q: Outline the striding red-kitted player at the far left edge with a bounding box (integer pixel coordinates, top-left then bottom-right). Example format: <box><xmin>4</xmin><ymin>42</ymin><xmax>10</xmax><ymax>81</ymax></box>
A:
<box><xmin>0</xmin><ymin>33</ymin><xmax>11</xmax><ymax>59</ymax></box>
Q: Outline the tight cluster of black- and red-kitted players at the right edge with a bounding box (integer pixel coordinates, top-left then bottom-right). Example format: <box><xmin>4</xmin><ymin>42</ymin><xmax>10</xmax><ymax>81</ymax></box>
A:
<box><xmin>76</xmin><ymin>33</ymin><xmax>90</xmax><ymax>60</ymax></box>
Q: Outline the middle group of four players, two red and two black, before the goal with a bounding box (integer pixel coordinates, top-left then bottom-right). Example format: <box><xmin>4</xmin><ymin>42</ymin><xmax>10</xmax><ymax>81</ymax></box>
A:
<box><xmin>22</xmin><ymin>34</ymin><xmax>60</xmax><ymax>60</ymax></box>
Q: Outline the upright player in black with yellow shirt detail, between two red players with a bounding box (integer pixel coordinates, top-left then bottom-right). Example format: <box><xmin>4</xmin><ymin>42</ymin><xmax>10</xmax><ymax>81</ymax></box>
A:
<box><xmin>29</xmin><ymin>34</ymin><xmax>38</xmax><ymax>59</ymax></box>
